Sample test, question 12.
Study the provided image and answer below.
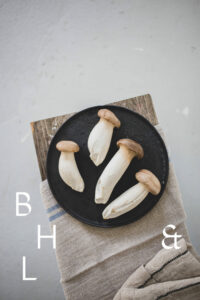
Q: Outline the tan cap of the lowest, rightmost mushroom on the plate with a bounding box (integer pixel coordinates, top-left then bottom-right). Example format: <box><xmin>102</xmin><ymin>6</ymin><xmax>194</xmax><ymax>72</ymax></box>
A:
<box><xmin>135</xmin><ymin>169</ymin><xmax>161</xmax><ymax>195</ymax></box>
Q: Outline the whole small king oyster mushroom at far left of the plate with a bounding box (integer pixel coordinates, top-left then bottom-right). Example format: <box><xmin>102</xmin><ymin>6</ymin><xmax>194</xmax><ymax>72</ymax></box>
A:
<box><xmin>56</xmin><ymin>141</ymin><xmax>84</xmax><ymax>192</ymax></box>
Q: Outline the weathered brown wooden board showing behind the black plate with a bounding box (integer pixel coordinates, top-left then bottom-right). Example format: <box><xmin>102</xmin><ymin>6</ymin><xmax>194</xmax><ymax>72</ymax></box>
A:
<box><xmin>31</xmin><ymin>94</ymin><xmax>158</xmax><ymax>180</ymax></box>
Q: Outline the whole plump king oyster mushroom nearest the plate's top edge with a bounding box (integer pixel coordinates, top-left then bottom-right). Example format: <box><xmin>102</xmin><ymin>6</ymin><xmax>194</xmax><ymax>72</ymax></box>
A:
<box><xmin>88</xmin><ymin>108</ymin><xmax>121</xmax><ymax>166</ymax></box>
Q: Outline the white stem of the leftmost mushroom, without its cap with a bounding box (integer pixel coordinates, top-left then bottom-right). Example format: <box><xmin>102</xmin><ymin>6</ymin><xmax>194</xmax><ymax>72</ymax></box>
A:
<box><xmin>58</xmin><ymin>152</ymin><xmax>84</xmax><ymax>192</ymax></box>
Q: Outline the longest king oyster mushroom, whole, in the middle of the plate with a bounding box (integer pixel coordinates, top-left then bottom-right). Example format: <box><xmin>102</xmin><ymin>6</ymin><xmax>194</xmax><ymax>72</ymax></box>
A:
<box><xmin>95</xmin><ymin>139</ymin><xmax>144</xmax><ymax>204</ymax></box>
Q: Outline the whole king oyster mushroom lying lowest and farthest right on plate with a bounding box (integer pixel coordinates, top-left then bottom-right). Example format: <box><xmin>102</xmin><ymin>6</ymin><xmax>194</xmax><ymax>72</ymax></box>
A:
<box><xmin>102</xmin><ymin>170</ymin><xmax>161</xmax><ymax>219</ymax></box>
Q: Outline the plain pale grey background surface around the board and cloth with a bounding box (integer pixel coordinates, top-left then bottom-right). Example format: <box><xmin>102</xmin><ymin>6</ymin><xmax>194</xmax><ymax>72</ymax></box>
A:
<box><xmin>0</xmin><ymin>0</ymin><xmax>200</xmax><ymax>300</ymax></box>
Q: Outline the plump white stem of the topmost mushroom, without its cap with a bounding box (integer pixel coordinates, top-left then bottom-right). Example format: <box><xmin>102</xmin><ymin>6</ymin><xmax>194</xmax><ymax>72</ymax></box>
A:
<box><xmin>88</xmin><ymin>118</ymin><xmax>114</xmax><ymax>166</ymax></box>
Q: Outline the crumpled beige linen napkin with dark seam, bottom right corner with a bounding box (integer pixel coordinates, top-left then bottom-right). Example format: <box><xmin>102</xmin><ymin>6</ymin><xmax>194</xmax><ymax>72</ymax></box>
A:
<box><xmin>114</xmin><ymin>239</ymin><xmax>200</xmax><ymax>300</ymax></box>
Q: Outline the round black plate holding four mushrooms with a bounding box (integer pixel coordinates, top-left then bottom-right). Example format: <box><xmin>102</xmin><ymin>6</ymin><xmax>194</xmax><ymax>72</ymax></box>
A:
<box><xmin>47</xmin><ymin>105</ymin><xmax>168</xmax><ymax>227</ymax></box>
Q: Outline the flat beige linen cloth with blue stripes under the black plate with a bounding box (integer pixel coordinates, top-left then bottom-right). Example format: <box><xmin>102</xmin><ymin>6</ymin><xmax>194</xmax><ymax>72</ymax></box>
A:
<box><xmin>41</xmin><ymin>128</ymin><xmax>200</xmax><ymax>300</ymax></box>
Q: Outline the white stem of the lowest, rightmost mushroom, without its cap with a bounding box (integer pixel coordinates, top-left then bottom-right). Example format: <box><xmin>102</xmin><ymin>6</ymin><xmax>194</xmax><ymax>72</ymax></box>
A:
<box><xmin>102</xmin><ymin>183</ymin><xmax>149</xmax><ymax>219</ymax></box>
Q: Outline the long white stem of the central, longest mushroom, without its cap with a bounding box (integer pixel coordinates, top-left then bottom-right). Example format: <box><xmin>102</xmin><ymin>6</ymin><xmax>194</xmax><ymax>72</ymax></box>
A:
<box><xmin>95</xmin><ymin>146</ymin><xmax>136</xmax><ymax>204</ymax></box>
